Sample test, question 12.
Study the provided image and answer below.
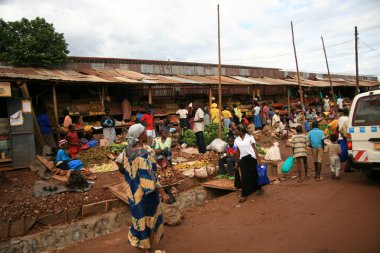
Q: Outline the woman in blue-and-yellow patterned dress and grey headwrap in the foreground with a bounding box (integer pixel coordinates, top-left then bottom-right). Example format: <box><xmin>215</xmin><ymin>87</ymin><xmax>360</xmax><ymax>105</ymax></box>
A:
<box><xmin>116</xmin><ymin>124</ymin><xmax>169</xmax><ymax>252</ymax></box>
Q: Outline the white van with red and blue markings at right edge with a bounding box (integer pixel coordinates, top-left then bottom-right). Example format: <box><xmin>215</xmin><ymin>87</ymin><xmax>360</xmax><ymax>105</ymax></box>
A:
<box><xmin>347</xmin><ymin>90</ymin><xmax>380</xmax><ymax>173</ymax></box>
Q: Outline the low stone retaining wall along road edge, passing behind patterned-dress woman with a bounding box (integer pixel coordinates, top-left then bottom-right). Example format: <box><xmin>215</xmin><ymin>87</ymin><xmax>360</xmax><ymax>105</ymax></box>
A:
<box><xmin>0</xmin><ymin>187</ymin><xmax>208</xmax><ymax>253</ymax></box>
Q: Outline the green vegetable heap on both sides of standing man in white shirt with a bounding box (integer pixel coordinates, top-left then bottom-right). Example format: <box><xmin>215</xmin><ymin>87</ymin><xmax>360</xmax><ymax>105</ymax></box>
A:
<box><xmin>179</xmin><ymin>123</ymin><xmax>228</xmax><ymax>146</ymax></box>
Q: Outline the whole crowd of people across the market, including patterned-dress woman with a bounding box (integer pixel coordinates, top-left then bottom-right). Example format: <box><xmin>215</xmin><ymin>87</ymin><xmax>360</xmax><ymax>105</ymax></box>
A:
<box><xmin>32</xmin><ymin>97</ymin><xmax>348</xmax><ymax>252</ymax></box>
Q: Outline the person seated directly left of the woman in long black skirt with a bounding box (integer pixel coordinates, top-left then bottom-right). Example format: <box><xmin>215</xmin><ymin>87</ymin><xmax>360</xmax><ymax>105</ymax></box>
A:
<box><xmin>217</xmin><ymin>137</ymin><xmax>237</xmax><ymax>180</ymax></box>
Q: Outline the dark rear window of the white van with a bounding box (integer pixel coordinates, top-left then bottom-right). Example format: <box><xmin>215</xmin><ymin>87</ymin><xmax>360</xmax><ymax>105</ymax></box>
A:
<box><xmin>352</xmin><ymin>94</ymin><xmax>380</xmax><ymax>126</ymax></box>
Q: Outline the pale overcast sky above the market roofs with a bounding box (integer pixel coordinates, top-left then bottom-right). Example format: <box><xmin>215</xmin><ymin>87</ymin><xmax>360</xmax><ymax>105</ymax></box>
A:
<box><xmin>0</xmin><ymin>0</ymin><xmax>380</xmax><ymax>76</ymax></box>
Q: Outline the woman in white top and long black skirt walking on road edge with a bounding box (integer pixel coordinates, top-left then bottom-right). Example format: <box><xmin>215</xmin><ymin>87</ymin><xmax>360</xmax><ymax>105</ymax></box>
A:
<box><xmin>235</xmin><ymin>125</ymin><xmax>263</xmax><ymax>203</ymax></box>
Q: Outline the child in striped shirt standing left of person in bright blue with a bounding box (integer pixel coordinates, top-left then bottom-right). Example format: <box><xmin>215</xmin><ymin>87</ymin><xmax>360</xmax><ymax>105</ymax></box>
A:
<box><xmin>291</xmin><ymin>125</ymin><xmax>309</xmax><ymax>182</ymax></box>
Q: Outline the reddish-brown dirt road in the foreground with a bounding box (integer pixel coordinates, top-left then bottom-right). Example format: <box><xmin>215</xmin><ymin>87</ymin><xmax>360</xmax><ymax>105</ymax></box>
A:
<box><xmin>58</xmin><ymin>172</ymin><xmax>380</xmax><ymax>253</ymax></box>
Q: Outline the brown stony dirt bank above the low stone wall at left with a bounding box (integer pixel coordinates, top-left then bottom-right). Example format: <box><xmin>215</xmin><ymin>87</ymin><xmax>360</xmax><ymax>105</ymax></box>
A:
<box><xmin>0</xmin><ymin>169</ymin><xmax>124</xmax><ymax>222</ymax></box>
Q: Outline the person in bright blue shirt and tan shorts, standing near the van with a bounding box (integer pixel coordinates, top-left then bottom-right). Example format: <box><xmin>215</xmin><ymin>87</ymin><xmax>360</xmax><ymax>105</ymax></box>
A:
<box><xmin>307</xmin><ymin>121</ymin><xmax>325</xmax><ymax>181</ymax></box>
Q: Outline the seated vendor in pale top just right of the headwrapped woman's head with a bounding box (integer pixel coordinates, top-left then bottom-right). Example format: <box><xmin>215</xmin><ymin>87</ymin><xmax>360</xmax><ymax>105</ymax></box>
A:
<box><xmin>154</xmin><ymin>127</ymin><xmax>172</xmax><ymax>168</ymax></box>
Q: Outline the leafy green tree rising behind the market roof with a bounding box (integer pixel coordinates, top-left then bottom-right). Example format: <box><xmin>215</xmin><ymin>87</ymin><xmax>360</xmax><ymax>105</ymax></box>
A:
<box><xmin>0</xmin><ymin>17</ymin><xmax>69</xmax><ymax>66</ymax></box>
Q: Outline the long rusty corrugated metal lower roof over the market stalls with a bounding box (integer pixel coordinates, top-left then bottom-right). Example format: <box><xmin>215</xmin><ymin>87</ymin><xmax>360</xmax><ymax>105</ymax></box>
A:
<box><xmin>0</xmin><ymin>67</ymin><xmax>380</xmax><ymax>87</ymax></box>
